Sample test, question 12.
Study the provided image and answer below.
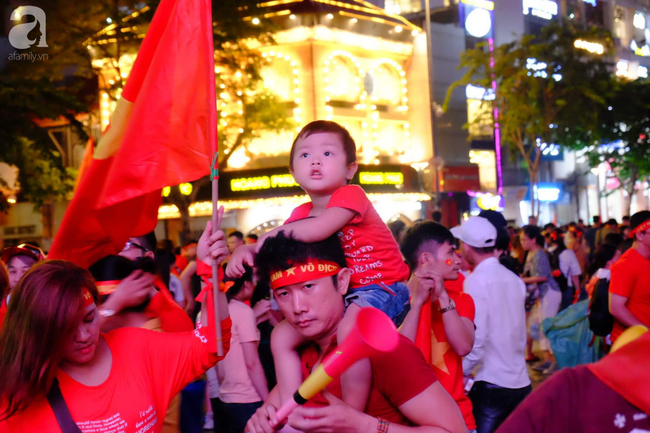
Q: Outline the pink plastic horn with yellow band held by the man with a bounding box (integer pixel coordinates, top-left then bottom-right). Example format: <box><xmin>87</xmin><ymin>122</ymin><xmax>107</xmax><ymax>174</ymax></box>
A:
<box><xmin>273</xmin><ymin>307</ymin><xmax>399</xmax><ymax>427</ymax></box>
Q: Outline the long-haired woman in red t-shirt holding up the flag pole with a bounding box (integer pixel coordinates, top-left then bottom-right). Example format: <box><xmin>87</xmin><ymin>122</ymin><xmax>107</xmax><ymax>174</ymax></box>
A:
<box><xmin>0</xmin><ymin>219</ymin><xmax>231</xmax><ymax>433</ymax></box>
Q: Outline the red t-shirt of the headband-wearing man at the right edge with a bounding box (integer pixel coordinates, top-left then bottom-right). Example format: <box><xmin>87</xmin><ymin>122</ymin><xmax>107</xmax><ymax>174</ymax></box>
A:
<box><xmin>609</xmin><ymin>248</ymin><xmax>650</xmax><ymax>342</ymax></box>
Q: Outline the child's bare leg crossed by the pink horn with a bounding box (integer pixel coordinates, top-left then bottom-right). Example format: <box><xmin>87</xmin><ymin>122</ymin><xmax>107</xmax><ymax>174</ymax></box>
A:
<box><xmin>337</xmin><ymin>304</ymin><xmax>372</xmax><ymax>412</ymax></box>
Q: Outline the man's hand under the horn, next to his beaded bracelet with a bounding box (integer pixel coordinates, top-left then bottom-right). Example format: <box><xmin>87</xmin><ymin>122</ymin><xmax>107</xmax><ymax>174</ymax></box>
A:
<box><xmin>289</xmin><ymin>390</ymin><xmax>377</xmax><ymax>433</ymax></box>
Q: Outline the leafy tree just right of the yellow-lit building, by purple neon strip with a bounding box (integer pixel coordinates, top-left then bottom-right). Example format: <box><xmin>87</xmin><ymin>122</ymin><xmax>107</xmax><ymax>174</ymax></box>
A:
<box><xmin>445</xmin><ymin>24</ymin><xmax>613</xmax><ymax>215</ymax></box>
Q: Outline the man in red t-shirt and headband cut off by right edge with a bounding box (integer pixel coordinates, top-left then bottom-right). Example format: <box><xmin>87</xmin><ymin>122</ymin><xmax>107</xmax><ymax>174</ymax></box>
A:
<box><xmin>609</xmin><ymin>210</ymin><xmax>650</xmax><ymax>342</ymax></box>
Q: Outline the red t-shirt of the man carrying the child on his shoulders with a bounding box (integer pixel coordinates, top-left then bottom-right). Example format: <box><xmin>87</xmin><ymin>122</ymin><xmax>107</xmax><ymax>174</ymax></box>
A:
<box><xmin>301</xmin><ymin>335</ymin><xmax>437</xmax><ymax>425</ymax></box>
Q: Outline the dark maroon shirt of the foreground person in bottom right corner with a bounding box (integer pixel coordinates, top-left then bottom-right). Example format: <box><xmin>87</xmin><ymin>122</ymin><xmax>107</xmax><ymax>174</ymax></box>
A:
<box><xmin>497</xmin><ymin>360</ymin><xmax>650</xmax><ymax>433</ymax></box>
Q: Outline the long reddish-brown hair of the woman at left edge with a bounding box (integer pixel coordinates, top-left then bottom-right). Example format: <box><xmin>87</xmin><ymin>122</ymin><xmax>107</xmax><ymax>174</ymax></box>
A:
<box><xmin>0</xmin><ymin>260</ymin><xmax>98</xmax><ymax>420</ymax></box>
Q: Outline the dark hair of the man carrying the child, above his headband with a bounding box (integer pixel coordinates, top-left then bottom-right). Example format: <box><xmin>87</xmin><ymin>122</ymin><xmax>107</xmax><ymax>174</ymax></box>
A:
<box><xmin>255</xmin><ymin>232</ymin><xmax>347</xmax><ymax>286</ymax></box>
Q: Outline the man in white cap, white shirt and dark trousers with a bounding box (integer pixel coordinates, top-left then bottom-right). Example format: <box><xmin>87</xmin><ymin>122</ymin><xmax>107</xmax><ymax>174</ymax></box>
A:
<box><xmin>451</xmin><ymin>217</ymin><xmax>532</xmax><ymax>433</ymax></box>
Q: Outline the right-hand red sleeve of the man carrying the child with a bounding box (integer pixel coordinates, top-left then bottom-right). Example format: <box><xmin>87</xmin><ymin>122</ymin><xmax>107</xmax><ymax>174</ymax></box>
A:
<box><xmin>371</xmin><ymin>335</ymin><xmax>438</xmax><ymax>407</ymax></box>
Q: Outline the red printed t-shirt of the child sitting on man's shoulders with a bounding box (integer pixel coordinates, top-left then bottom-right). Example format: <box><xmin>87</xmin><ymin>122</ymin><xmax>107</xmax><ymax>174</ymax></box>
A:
<box><xmin>285</xmin><ymin>185</ymin><xmax>410</xmax><ymax>289</ymax></box>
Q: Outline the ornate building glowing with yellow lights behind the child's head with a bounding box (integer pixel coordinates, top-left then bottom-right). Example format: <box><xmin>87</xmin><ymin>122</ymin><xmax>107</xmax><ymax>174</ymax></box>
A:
<box><xmin>89</xmin><ymin>0</ymin><xmax>433</xmax><ymax>238</ymax></box>
